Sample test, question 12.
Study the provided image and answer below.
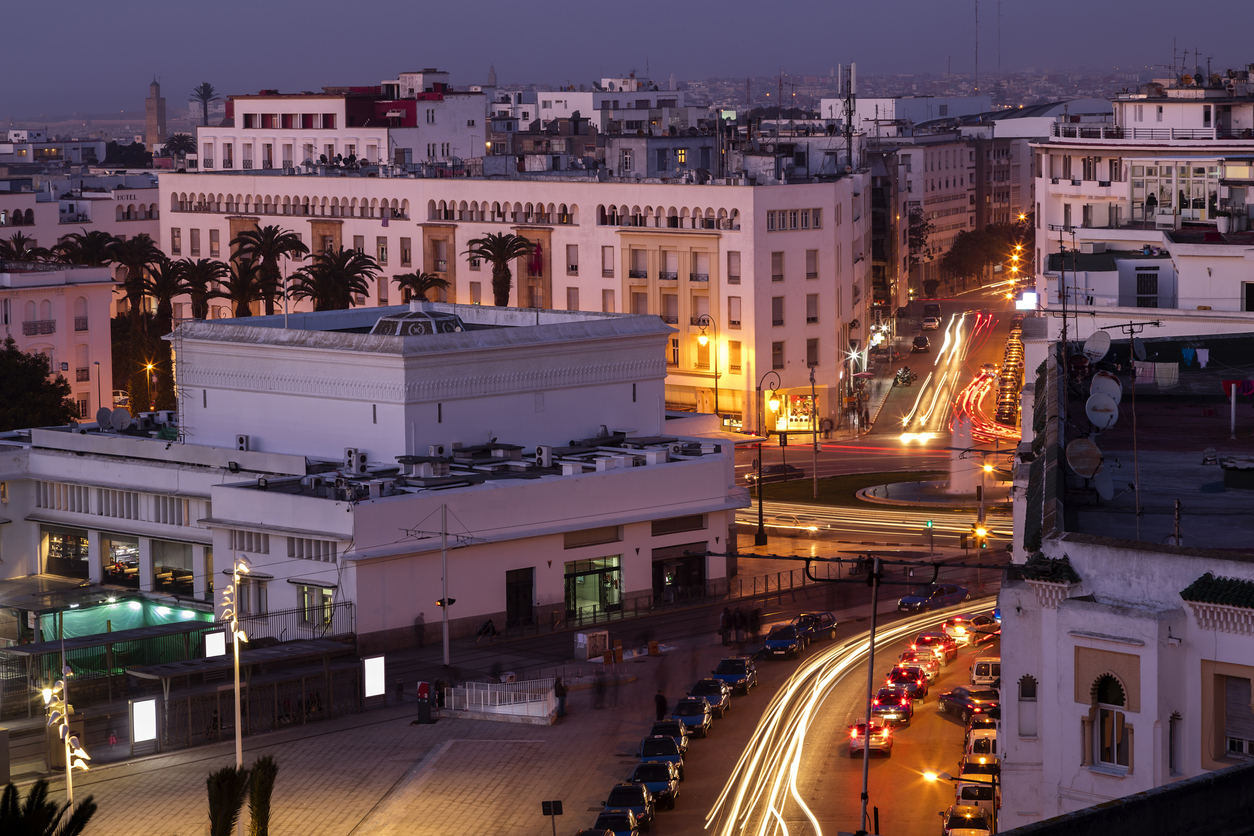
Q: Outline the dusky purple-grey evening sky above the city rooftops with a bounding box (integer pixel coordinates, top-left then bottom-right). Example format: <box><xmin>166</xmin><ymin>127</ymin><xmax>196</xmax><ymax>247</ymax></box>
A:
<box><xmin>0</xmin><ymin>0</ymin><xmax>1254</xmax><ymax>118</ymax></box>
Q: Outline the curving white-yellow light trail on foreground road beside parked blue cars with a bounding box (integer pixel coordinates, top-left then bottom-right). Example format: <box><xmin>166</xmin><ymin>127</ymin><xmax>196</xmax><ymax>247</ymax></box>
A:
<box><xmin>705</xmin><ymin>598</ymin><xmax>996</xmax><ymax>836</ymax></box>
